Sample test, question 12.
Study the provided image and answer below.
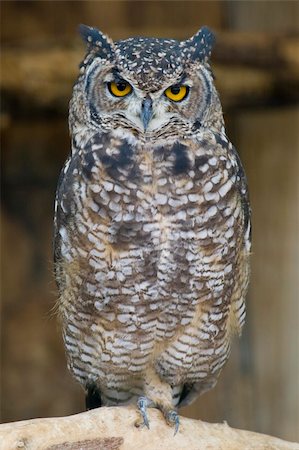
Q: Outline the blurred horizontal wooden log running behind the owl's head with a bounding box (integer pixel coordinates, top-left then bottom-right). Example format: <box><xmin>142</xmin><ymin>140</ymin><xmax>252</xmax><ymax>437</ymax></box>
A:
<box><xmin>0</xmin><ymin>33</ymin><xmax>299</xmax><ymax>113</ymax></box>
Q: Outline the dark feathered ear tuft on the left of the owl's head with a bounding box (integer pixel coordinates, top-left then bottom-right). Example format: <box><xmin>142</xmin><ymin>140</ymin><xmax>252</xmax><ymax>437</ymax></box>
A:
<box><xmin>79</xmin><ymin>24</ymin><xmax>113</xmax><ymax>58</ymax></box>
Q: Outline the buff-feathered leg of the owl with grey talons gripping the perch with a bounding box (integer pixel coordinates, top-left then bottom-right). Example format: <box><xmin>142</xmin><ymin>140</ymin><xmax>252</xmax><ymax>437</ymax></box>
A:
<box><xmin>137</xmin><ymin>369</ymin><xmax>180</xmax><ymax>434</ymax></box>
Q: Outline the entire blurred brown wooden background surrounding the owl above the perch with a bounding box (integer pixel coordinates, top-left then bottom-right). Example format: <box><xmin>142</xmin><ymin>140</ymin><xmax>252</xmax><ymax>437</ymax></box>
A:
<box><xmin>0</xmin><ymin>0</ymin><xmax>299</xmax><ymax>440</ymax></box>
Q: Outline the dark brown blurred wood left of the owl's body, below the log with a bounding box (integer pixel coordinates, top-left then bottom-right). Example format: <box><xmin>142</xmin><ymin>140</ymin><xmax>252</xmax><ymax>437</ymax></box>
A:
<box><xmin>0</xmin><ymin>117</ymin><xmax>84</xmax><ymax>422</ymax></box>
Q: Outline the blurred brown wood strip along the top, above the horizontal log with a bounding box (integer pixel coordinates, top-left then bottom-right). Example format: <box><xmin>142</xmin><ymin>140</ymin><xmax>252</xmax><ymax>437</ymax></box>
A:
<box><xmin>1</xmin><ymin>0</ymin><xmax>225</xmax><ymax>44</ymax></box>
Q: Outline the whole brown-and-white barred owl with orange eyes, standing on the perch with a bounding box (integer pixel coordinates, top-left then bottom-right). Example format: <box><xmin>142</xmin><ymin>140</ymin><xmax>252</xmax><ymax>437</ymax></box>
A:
<box><xmin>54</xmin><ymin>25</ymin><xmax>250</xmax><ymax>431</ymax></box>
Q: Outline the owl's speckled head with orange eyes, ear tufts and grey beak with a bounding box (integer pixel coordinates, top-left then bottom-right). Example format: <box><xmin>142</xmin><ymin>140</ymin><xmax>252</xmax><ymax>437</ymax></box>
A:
<box><xmin>71</xmin><ymin>25</ymin><xmax>222</xmax><ymax>141</ymax></box>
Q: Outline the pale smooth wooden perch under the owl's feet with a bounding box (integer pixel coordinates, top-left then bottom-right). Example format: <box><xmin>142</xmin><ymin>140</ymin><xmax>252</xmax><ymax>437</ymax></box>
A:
<box><xmin>0</xmin><ymin>407</ymin><xmax>299</xmax><ymax>450</ymax></box>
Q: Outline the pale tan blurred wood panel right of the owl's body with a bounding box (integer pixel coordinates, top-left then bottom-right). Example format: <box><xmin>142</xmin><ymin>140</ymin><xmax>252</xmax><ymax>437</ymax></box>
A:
<box><xmin>234</xmin><ymin>107</ymin><xmax>299</xmax><ymax>439</ymax></box>
